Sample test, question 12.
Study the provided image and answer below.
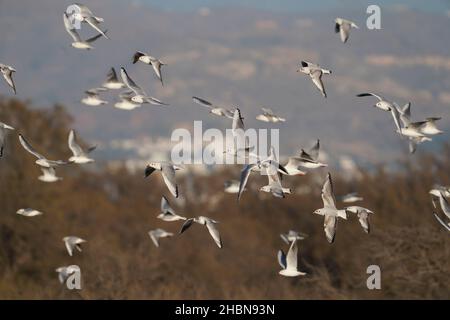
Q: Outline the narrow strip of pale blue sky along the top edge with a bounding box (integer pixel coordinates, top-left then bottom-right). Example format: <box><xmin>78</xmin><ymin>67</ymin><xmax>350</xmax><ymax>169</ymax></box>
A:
<box><xmin>135</xmin><ymin>0</ymin><xmax>450</xmax><ymax>13</ymax></box>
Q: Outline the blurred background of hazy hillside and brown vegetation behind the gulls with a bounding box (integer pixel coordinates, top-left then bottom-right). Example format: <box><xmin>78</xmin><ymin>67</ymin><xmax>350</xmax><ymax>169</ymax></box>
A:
<box><xmin>0</xmin><ymin>0</ymin><xmax>450</xmax><ymax>299</ymax></box>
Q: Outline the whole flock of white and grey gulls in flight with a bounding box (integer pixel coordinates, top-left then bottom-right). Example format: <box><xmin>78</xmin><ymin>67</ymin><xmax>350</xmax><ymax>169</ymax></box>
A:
<box><xmin>0</xmin><ymin>4</ymin><xmax>450</xmax><ymax>283</ymax></box>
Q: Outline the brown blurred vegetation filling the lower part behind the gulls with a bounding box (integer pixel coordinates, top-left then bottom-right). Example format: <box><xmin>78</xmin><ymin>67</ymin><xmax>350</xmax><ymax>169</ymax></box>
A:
<box><xmin>0</xmin><ymin>100</ymin><xmax>450</xmax><ymax>299</ymax></box>
